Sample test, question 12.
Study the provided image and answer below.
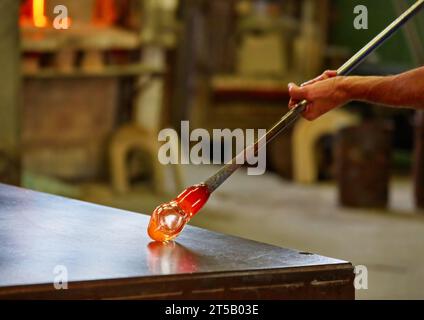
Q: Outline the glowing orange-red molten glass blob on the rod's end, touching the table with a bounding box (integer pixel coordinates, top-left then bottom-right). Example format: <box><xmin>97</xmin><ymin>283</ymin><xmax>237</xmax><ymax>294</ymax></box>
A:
<box><xmin>148</xmin><ymin>184</ymin><xmax>210</xmax><ymax>242</ymax></box>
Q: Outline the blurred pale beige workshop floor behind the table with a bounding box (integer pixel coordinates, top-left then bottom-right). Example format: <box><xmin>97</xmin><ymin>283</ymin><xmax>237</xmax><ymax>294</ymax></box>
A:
<box><xmin>84</xmin><ymin>166</ymin><xmax>424</xmax><ymax>299</ymax></box>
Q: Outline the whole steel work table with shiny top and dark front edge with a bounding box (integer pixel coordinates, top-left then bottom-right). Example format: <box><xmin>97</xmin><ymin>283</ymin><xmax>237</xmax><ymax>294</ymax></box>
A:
<box><xmin>0</xmin><ymin>184</ymin><xmax>355</xmax><ymax>299</ymax></box>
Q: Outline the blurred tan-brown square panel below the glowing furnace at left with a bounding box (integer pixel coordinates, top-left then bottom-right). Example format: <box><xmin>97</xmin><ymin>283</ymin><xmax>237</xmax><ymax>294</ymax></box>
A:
<box><xmin>22</xmin><ymin>78</ymin><xmax>118</xmax><ymax>179</ymax></box>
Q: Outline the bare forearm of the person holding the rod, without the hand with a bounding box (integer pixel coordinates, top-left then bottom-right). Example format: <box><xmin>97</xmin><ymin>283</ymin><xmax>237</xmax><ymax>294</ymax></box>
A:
<box><xmin>340</xmin><ymin>67</ymin><xmax>424</xmax><ymax>109</ymax></box>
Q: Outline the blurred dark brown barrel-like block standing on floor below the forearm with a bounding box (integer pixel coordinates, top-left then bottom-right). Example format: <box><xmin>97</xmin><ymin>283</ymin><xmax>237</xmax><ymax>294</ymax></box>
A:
<box><xmin>335</xmin><ymin>122</ymin><xmax>392</xmax><ymax>208</ymax></box>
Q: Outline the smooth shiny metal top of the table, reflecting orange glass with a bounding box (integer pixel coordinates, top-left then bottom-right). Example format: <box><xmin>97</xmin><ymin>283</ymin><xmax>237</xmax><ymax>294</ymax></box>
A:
<box><xmin>0</xmin><ymin>184</ymin><xmax>352</xmax><ymax>289</ymax></box>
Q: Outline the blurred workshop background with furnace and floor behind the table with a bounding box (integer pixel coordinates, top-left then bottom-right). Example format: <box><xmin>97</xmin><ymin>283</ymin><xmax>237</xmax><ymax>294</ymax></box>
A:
<box><xmin>0</xmin><ymin>0</ymin><xmax>424</xmax><ymax>299</ymax></box>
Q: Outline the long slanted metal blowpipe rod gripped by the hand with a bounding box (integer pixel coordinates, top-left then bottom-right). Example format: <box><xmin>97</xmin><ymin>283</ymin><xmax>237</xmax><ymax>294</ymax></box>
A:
<box><xmin>204</xmin><ymin>0</ymin><xmax>424</xmax><ymax>193</ymax></box>
